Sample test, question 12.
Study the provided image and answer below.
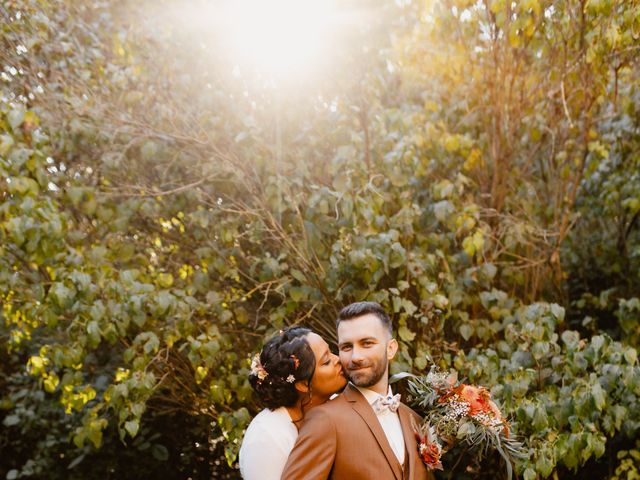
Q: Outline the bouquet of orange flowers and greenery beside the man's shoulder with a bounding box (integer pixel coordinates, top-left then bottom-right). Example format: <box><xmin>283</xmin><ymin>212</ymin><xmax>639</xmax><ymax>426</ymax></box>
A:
<box><xmin>409</xmin><ymin>367</ymin><xmax>526</xmax><ymax>479</ymax></box>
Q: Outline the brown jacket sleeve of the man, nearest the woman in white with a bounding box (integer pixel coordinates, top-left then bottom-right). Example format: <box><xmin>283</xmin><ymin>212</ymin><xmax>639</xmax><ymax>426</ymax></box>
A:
<box><xmin>282</xmin><ymin>408</ymin><xmax>337</xmax><ymax>480</ymax></box>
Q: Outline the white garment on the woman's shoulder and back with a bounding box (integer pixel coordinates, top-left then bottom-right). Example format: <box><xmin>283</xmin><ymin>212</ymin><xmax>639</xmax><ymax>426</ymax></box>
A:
<box><xmin>240</xmin><ymin>407</ymin><xmax>298</xmax><ymax>480</ymax></box>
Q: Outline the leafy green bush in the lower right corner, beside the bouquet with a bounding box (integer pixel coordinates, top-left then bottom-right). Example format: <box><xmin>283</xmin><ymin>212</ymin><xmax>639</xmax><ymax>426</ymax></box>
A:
<box><xmin>453</xmin><ymin>304</ymin><xmax>640</xmax><ymax>478</ymax></box>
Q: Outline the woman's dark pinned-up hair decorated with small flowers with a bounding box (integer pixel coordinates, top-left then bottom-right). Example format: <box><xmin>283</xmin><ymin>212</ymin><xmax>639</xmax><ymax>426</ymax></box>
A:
<box><xmin>249</xmin><ymin>327</ymin><xmax>316</xmax><ymax>410</ymax></box>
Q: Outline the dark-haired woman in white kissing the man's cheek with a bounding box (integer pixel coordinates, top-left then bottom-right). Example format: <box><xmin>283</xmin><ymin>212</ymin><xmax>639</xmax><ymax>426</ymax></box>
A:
<box><xmin>240</xmin><ymin>327</ymin><xmax>347</xmax><ymax>480</ymax></box>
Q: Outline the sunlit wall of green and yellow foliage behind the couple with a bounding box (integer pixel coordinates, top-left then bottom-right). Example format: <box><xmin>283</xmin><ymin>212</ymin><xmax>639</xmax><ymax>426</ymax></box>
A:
<box><xmin>0</xmin><ymin>0</ymin><xmax>640</xmax><ymax>478</ymax></box>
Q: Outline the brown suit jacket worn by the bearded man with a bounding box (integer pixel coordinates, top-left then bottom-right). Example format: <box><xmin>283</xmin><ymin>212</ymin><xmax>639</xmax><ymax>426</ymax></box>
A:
<box><xmin>282</xmin><ymin>384</ymin><xmax>432</xmax><ymax>480</ymax></box>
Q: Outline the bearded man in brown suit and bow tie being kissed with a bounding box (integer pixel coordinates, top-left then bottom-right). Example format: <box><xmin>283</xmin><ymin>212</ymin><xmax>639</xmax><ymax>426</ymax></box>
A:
<box><xmin>282</xmin><ymin>302</ymin><xmax>431</xmax><ymax>480</ymax></box>
